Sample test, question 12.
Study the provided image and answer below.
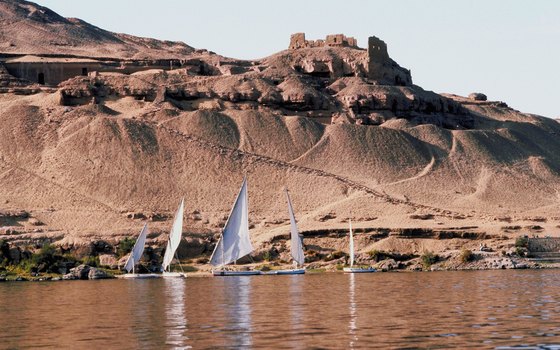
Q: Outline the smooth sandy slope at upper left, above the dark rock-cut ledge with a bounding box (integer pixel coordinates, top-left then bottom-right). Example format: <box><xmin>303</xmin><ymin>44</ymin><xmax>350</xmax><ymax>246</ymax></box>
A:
<box><xmin>0</xmin><ymin>0</ymin><xmax>193</xmax><ymax>59</ymax></box>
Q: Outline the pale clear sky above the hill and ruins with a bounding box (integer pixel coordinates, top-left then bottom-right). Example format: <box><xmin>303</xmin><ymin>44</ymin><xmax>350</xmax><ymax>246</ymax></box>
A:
<box><xmin>35</xmin><ymin>0</ymin><xmax>560</xmax><ymax>118</ymax></box>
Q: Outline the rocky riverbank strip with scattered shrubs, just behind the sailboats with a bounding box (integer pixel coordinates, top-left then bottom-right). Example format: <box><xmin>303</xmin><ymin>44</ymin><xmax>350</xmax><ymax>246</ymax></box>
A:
<box><xmin>0</xmin><ymin>227</ymin><xmax>560</xmax><ymax>281</ymax></box>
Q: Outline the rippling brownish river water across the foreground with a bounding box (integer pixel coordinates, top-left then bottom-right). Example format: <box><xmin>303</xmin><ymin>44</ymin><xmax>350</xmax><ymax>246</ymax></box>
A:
<box><xmin>0</xmin><ymin>270</ymin><xmax>560</xmax><ymax>350</ymax></box>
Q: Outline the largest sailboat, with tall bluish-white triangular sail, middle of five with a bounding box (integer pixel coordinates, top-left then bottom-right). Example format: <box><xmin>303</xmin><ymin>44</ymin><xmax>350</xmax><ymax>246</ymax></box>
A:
<box><xmin>210</xmin><ymin>178</ymin><xmax>261</xmax><ymax>276</ymax></box>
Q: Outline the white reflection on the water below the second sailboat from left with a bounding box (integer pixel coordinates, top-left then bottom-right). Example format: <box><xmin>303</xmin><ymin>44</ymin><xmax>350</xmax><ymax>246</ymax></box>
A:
<box><xmin>163</xmin><ymin>278</ymin><xmax>191</xmax><ymax>349</ymax></box>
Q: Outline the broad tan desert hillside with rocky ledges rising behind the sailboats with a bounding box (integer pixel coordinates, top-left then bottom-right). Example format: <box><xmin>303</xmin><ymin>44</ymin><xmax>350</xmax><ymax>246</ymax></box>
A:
<box><xmin>0</xmin><ymin>0</ymin><xmax>560</xmax><ymax>260</ymax></box>
